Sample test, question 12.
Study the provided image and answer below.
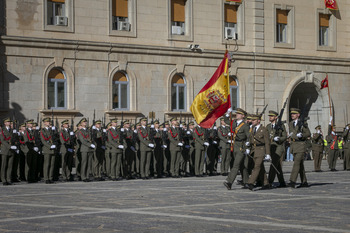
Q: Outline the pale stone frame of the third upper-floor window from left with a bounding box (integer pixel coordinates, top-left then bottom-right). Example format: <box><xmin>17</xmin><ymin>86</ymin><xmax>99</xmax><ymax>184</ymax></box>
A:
<box><xmin>168</xmin><ymin>0</ymin><xmax>193</xmax><ymax>42</ymax></box>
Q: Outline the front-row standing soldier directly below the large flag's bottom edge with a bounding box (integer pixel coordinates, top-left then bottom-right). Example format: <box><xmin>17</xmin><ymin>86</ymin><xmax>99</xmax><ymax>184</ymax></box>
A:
<box><xmin>193</xmin><ymin>125</ymin><xmax>209</xmax><ymax>177</ymax></box>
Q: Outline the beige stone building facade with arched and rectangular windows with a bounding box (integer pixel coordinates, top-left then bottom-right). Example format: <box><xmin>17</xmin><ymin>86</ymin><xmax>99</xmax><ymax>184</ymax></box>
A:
<box><xmin>0</xmin><ymin>0</ymin><xmax>350</xmax><ymax>129</ymax></box>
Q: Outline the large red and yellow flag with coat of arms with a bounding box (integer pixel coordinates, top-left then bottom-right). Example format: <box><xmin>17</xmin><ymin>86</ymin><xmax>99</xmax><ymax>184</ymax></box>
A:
<box><xmin>191</xmin><ymin>51</ymin><xmax>231</xmax><ymax>128</ymax></box>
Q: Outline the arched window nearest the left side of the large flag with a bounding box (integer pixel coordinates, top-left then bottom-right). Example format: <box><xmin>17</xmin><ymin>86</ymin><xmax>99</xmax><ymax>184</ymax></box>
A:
<box><xmin>171</xmin><ymin>74</ymin><xmax>186</xmax><ymax>111</ymax></box>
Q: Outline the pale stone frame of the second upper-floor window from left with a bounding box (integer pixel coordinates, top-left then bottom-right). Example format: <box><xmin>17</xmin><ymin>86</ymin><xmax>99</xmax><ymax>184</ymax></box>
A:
<box><xmin>108</xmin><ymin>0</ymin><xmax>137</xmax><ymax>37</ymax></box>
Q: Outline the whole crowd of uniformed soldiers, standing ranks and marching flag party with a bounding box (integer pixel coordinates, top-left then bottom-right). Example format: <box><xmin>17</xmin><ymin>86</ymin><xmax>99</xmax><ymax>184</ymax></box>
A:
<box><xmin>0</xmin><ymin>108</ymin><xmax>350</xmax><ymax>190</ymax></box>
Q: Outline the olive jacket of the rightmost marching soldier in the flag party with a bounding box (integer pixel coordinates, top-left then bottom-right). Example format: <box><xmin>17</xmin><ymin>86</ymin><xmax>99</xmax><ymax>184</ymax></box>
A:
<box><xmin>289</xmin><ymin>121</ymin><xmax>311</xmax><ymax>154</ymax></box>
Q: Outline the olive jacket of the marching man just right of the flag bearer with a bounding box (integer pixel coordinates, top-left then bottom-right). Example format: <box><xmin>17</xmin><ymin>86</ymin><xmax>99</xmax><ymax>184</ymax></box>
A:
<box><xmin>249</xmin><ymin>125</ymin><xmax>271</xmax><ymax>156</ymax></box>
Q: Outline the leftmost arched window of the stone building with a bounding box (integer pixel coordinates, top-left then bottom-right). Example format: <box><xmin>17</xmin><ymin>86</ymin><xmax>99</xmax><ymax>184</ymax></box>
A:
<box><xmin>47</xmin><ymin>67</ymin><xmax>67</xmax><ymax>109</ymax></box>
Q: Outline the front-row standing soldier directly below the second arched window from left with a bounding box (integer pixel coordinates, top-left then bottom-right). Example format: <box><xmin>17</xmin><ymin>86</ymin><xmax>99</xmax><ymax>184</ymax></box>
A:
<box><xmin>108</xmin><ymin>119</ymin><xmax>125</xmax><ymax>181</ymax></box>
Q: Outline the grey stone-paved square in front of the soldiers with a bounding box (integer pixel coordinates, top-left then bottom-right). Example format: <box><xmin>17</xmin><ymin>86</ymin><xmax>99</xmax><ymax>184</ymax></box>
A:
<box><xmin>0</xmin><ymin>160</ymin><xmax>350</xmax><ymax>232</ymax></box>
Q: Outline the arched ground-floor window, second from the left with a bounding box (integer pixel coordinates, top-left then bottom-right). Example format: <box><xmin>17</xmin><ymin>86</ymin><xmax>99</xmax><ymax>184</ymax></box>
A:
<box><xmin>112</xmin><ymin>72</ymin><xmax>129</xmax><ymax>110</ymax></box>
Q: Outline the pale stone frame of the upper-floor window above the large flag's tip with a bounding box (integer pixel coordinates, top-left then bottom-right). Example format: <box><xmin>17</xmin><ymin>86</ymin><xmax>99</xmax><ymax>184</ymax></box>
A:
<box><xmin>221</xmin><ymin>0</ymin><xmax>246</xmax><ymax>45</ymax></box>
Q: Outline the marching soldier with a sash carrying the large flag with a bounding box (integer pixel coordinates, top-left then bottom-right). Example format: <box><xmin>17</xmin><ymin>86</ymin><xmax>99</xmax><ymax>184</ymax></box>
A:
<box><xmin>224</xmin><ymin>108</ymin><xmax>250</xmax><ymax>190</ymax></box>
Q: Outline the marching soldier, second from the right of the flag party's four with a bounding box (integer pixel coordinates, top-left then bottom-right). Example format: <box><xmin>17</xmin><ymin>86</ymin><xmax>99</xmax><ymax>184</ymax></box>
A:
<box><xmin>266</xmin><ymin>111</ymin><xmax>287</xmax><ymax>187</ymax></box>
